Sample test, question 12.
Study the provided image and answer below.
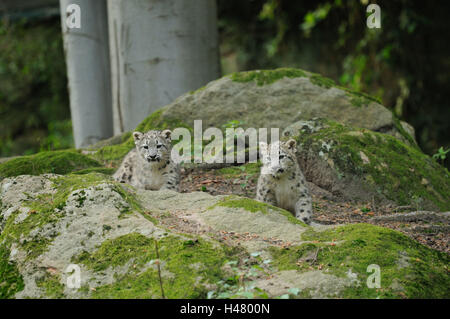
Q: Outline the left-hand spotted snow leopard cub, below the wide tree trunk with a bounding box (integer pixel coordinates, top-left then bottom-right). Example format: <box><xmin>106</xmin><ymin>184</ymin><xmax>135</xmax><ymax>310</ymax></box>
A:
<box><xmin>113</xmin><ymin>130</ymin><xmax>180</xmax><ymax>191</ymax></box>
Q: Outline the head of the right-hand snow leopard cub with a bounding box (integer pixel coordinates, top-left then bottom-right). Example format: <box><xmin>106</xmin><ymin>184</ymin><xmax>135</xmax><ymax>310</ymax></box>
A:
<box><xmin>259</xmin><ymin>139</ymin><xmax>298</xmax><ymax>177</ymax></box>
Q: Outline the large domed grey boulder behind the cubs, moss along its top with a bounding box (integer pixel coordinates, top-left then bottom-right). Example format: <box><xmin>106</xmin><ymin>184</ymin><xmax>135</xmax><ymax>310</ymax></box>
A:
<box><xmin>140</xmin><ymin>68</ymin><xmax>415</xmax><ymax>145</ymax></box>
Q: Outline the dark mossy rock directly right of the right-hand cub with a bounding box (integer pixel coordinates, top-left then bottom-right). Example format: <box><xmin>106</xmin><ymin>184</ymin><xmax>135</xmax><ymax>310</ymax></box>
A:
<box><xmin>283</xmin><ymin>119</ymin><xmax>450</xmax><ymax>210</ymax></box>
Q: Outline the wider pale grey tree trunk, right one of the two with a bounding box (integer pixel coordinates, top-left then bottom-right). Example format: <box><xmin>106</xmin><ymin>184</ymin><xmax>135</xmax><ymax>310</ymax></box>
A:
<box><xmin>108</xmin><ymin>0</ymin><xmax>220</xmax><ymax>134</ymax></box>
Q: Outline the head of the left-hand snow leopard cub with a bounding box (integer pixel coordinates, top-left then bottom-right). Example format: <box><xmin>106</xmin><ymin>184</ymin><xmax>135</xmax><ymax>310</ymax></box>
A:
<box><xmin>133</xmin><ymin>130</ymin><xmax>172</xmax><ymax>163</ymax></box>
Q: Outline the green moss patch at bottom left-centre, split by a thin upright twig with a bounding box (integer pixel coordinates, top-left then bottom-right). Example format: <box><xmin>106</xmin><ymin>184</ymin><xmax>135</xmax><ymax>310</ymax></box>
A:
<box><xmin>74</xmin><ymin>233</ymin><xmax>237</xmax><ymax>298</ymax></box>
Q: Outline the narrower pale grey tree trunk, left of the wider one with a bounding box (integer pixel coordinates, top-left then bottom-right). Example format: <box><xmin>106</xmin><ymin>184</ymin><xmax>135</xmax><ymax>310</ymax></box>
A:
<box><xmin>60</xmin><ymin>0</ymin><xmax>113</xmax><ymax>148</ymax></box>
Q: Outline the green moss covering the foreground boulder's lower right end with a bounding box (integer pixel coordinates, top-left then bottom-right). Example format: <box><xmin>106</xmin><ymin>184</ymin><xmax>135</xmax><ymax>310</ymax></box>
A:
<box><xmin>271</xmin><ymin>224</ymin><xmax>450</xmax><ymax>298</ymax></box>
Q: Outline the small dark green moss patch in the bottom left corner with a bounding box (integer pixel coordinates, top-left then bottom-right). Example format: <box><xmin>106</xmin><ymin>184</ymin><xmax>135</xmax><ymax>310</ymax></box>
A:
<box><xmin>0</xmin><ymin>245</ymin><xmax>24</xmax><ymax>299</ymax></box>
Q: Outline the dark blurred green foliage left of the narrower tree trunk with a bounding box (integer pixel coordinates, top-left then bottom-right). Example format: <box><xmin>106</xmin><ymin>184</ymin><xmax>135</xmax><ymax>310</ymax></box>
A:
<box><xmin>0</xmin><ymin>18</ymin><xmax>73</xmax><ymax>156</ymax></box>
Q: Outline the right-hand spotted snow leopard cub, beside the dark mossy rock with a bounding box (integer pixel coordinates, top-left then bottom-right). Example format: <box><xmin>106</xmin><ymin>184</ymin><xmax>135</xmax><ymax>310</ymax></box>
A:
<box><xmin>256</xmin><ymin>139</ymin><xmax>313</xmax><ymax>224</ymax></box>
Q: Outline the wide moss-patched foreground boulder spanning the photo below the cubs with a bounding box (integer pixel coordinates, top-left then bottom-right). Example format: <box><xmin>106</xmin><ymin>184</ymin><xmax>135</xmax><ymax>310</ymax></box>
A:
<box><xmin>0</xmin><ymin>173</ymin><xmax>450</xmax><ymax>298</ymax></box>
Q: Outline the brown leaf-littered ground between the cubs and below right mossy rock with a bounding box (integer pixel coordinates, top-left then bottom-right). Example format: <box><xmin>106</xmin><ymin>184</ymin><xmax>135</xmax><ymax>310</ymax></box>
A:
<box><xmin>178</xmin><ymin>165</ymin><xmax>450</xmax><ymax>253</ymax></box>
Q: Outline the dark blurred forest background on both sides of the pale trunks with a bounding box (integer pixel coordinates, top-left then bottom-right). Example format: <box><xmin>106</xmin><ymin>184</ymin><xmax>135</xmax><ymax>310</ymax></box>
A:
<box><xmin>0</xmin><ymin>0</ymin><xmax>450</xmax><ymax>167</ymax></box>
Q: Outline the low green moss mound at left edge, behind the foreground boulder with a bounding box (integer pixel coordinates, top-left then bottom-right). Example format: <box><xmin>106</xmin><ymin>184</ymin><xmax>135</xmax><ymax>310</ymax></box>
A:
<box><xmin>0</xmin><ymin>150</ymin><xmax>100</xmax><ymax>180</ymax></box>
